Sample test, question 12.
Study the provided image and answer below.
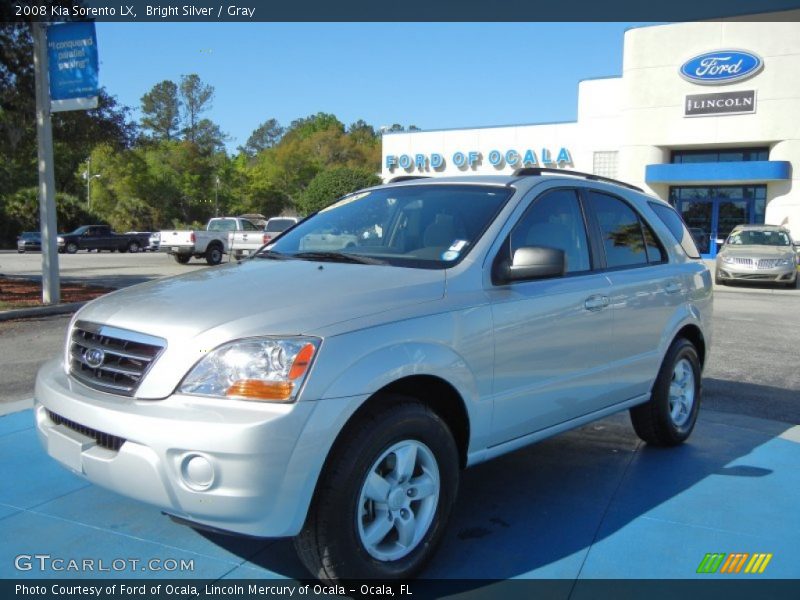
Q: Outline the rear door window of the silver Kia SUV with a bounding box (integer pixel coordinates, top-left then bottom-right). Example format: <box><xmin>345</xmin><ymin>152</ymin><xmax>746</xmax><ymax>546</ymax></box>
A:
<box><xmin>588</xmin><ymin>192</ymin><xmax>647</xmax><ymax>269</ymax></box>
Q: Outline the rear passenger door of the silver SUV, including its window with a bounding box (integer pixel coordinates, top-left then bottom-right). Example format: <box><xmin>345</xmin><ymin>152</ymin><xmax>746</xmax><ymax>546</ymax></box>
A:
<box><xmin>584</xmin><ymin>189</ymin><xmax>687</xmax><ymax>400</ymax></box>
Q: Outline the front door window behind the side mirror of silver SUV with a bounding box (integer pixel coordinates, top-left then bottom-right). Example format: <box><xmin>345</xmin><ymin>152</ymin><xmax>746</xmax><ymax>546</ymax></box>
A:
<box><xmin>511</xmin><ymin>189</ymin><xmax>591</xmax><ymax>273</ymax></box>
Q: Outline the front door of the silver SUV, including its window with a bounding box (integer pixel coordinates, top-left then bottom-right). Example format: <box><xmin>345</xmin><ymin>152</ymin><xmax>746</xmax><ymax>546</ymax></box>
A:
<box><xmin>489</xmin><ymin>188</ymin><xmax>613</xmax><ymax>444</ymax></box>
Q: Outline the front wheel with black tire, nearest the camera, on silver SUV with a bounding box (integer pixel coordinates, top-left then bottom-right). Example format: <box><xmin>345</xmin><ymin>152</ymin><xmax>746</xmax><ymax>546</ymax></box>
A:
<box><xmin>295</xmin><ymin>396</ymin><xmax>459</xmax><ymax>581</ymax></box>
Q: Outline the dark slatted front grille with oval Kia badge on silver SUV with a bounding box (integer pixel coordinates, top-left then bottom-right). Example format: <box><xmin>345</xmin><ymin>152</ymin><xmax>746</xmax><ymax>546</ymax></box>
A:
<box><xmin>68</xmin><ymin>321</ymin><xmax>166</xmax><ymax>396</ymax></box>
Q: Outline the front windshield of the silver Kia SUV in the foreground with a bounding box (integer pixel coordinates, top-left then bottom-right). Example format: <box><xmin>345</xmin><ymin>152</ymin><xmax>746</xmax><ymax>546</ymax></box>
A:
<box><xmin>267</xmin><ymin>185</ymin><xmax>514</xmax><ymax>269</ymax></box>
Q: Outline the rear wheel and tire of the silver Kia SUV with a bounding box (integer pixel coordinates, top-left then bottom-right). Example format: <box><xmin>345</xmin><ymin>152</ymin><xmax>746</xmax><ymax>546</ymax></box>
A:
<box><xmin>630</xmin><ymin>338</ymin><xmax>701</xmax><ymax>446</ymax></box>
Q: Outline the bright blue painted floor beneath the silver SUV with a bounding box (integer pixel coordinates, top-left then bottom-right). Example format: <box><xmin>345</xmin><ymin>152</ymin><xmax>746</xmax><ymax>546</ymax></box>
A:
<box><xmin>0</xmin><ymin>410</ymin><xmax>800</xmax><ymax>580</ymax></box>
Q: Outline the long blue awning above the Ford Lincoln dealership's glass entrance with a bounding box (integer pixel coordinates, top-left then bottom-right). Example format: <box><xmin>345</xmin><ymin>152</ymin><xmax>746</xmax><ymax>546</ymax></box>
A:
<box><xmin>644</xmin><ymin>160</ymin><xmax>792</xmax><ymax>184</ymax></box>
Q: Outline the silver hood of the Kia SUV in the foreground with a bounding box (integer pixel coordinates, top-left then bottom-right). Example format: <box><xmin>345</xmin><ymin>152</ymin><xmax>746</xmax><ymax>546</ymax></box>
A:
<box><xmin>76</xmin><ymin>259</ymin><xmax>445</xmax><ymax>398</ymax></box>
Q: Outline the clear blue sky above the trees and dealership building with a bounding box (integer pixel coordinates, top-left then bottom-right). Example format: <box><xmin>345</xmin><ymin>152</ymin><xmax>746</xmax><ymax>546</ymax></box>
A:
<box><xmin>97</xmin><ymin>23</ymin><xmax>656</xmax><ymax>151</ymax></box>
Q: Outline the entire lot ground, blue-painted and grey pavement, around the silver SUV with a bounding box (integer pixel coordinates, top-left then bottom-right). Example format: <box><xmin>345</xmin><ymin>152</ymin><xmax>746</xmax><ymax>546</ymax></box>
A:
<box><xmin>0</xmin><ymin>253</ymin><xmax>800</xmax><ymax>585</ymax></box>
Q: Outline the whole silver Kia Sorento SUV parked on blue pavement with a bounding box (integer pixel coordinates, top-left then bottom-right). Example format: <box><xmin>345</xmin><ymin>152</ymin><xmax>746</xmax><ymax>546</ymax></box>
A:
<box><xmin>35</xmin><ymin>169</ymin><xmax>712</xmax><ymax>581</ymax></box>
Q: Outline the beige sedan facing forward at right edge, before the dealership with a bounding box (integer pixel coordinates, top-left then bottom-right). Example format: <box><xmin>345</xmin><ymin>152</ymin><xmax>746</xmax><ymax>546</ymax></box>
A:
<box><xmin>714</xmin><ymin>225</ymin><xmax>797</xmax><ymax>288</ymax></box>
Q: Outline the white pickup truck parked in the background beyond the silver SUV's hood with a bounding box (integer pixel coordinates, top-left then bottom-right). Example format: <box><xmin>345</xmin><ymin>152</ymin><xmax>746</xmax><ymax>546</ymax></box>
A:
<box><xmin>159</xmin><ymin>217</ymin><xmax>263</xmax><ymax>265</ymax></box>
